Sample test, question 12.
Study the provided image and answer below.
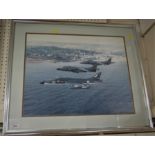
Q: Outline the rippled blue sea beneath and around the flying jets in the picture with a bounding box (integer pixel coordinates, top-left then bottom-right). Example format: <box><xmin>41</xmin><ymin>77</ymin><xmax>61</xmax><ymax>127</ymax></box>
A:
<box><xmin>23</xmin><ymin>57</ymin><xmax>134</xmax><ymax>117</ymax></box>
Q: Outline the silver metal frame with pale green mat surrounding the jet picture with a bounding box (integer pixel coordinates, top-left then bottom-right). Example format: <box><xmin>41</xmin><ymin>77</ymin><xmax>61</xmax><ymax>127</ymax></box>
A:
<box><xmin>3</xmin><ymin>20</ymin><xmax>153</xmax><ymax>135</ymax></box>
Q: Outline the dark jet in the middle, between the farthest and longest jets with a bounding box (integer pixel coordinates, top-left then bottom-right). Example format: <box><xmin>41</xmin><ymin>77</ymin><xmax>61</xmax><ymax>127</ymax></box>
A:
<box><xmin>57</xmin><ymin>65</ymin><xmax>97</xmax><ymax>73</ymax></box>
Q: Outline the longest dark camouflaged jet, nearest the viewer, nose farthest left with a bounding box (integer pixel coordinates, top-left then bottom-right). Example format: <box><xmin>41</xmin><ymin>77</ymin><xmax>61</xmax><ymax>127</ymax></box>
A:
<box><xmin>40</xmin><ymin>72</ymin><xmax>101</xmax><ymax>84</ymax></box>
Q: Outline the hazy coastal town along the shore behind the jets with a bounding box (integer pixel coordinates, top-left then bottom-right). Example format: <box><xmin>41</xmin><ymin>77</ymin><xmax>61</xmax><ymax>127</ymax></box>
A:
<box><xmin>26</xmin><ymin>46</ymin><xmax>101</xmax><ymax>62</ymax></box>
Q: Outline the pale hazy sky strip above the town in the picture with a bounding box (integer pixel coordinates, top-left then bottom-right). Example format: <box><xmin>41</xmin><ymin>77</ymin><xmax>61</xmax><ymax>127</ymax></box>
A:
<box><xmin>27</xmin><ymin>34</ymin><xmax>125</xmax><ymax>52</ymax></box>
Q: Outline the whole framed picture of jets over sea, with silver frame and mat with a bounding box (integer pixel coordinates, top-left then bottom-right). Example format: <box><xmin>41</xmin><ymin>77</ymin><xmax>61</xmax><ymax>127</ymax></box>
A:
<box><xmin>4</xmin><ymin>21</ymin><xmax>152</xmax><ymax>134</ymax></box>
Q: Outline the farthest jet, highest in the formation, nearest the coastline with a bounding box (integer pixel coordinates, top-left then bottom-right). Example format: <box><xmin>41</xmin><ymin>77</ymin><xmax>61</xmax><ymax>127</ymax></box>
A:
<box><xmin>81</xmin><ymin>57</ymin><xmax>112</xmax><ymax>65</ymax></box>
